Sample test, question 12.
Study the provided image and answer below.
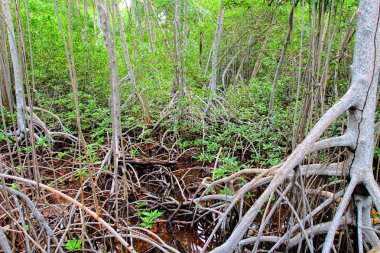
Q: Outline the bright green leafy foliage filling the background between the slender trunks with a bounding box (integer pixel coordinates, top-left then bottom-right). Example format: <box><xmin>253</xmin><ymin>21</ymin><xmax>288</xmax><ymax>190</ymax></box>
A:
<box><xmin>9</xmin><ymin>0</ymin><xmax>362</xmax><ymax>200</ymax></box>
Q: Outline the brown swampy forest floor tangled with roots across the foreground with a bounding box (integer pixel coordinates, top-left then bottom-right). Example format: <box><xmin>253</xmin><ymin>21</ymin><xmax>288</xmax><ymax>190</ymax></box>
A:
<box><xmin>0</xmin><ymin>129</ymin><xmax>378</xmax><ymax>253</ymax></box>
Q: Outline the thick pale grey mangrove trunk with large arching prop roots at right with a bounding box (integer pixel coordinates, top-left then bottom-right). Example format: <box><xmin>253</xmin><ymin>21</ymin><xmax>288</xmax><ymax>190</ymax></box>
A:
<box><xmin>208</xmin><ymin>0</ymin><xmax>380</xmax><ymax>253</ymax></box>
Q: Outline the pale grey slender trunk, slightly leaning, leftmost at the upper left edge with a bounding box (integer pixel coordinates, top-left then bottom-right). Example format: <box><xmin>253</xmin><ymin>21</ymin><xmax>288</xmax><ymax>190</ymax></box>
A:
<box><xmin>2</xmin><ymin>0</ymin><xmax>26</xmax><ymax>133</ymax></box>
